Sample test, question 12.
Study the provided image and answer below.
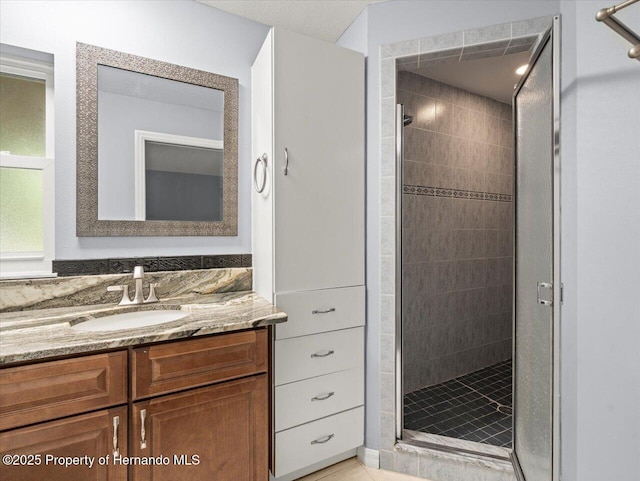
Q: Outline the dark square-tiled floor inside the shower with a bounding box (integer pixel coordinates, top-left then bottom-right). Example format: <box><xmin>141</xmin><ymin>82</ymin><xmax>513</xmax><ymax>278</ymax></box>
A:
<box><xmin>404</xmin><ymin>360</ymin><xmax>512</xmax><ymax>448</ymax></box>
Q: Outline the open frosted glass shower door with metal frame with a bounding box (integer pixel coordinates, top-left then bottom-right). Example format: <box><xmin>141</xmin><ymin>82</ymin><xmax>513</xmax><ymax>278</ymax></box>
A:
<box><xmin>513</xmin><ymin>19</ymin><xmax>557</xmax><ymax>481</ymax></box>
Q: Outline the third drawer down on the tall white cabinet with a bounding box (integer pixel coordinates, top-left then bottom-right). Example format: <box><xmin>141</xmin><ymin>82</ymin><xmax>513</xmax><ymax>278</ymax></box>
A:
<box><xmin>275</xmin><ymin>367</ymin><xmax>364</xmax><ymax>432</ymax></box>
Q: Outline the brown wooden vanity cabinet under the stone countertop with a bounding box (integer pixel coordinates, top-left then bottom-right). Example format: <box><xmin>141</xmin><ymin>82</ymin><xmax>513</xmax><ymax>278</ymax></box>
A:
<box><xmin>0</xmin><ymin>328</ymin><xmax>269</xmax><ymax>481</ymax></box>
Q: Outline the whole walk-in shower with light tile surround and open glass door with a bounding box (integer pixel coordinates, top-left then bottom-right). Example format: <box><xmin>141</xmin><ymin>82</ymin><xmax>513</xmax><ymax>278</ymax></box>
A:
<box><xmin>380</xmin><ymin>16</ymin><xmax>562</xmax><ymax>481</ymax></box>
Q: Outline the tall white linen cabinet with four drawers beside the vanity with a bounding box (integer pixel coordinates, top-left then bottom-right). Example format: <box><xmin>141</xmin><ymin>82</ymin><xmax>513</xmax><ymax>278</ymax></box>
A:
<box><xmin>251</xmin><ymin>28</ymin><xmax>365</xmax><ymax>481</ymax></box>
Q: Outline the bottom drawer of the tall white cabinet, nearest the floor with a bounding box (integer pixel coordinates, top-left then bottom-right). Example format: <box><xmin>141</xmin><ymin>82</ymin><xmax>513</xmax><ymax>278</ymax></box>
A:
<box><xmin>276</xmin><ymin>407</ymin><xmax>364</xmax><ymax>477</ymax></box>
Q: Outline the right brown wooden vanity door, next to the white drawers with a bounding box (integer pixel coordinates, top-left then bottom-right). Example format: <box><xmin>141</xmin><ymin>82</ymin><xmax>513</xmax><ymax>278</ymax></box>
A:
<box><xmin>131</xmin><ymin>374</ymin><xmax>269</xmax><ymax>481</ymax></box>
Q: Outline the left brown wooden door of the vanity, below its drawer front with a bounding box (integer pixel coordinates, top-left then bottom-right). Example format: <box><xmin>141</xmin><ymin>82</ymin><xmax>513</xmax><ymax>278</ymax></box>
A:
<box><xmin>0</xmin><ymin>407</ymin><xmax>127</xmax><ymax>481</ymax></box>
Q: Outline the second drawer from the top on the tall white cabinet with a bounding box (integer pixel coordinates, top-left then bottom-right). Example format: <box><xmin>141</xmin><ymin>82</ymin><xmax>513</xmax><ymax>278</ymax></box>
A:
<box><xmin>274</xmin><ymin>327</ymin><xmax>364</xmax><ymax>386</ymax></box>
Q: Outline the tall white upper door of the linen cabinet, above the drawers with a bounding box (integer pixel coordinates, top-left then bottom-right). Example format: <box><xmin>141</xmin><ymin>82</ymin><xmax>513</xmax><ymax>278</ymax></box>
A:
<box><xmin>273</xmin><ymin>29</ymin><xmax>365</xmax><ymax>293</ymax></box>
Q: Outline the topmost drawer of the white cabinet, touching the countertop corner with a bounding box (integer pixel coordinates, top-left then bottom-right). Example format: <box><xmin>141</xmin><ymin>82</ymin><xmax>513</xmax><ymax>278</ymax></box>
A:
<box><xmin>276</xmin><ymin>286</ymin><xmax>365</xmax><ymax>339</ymax></box>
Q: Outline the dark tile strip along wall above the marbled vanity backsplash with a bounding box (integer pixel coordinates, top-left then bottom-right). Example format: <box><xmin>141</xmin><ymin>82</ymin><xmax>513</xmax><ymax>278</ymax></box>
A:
<box><xmin>53</xmin><ymin>254</ymin><xmax>252</xmax><ymax>277</ymax></box>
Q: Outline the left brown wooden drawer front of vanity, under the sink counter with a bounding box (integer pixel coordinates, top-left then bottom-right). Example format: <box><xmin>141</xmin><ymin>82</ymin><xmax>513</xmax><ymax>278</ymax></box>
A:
<box><xmin>0</xmin><ymin>351</ymin><xmax>127</xmax><ymax>430</ymax></box>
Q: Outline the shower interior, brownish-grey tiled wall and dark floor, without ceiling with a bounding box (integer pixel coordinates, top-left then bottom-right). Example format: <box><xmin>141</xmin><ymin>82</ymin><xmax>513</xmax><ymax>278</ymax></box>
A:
<box><xmin>397</xmin><ymin>70</ymin><xmax>514</xmax><ymax>448</ymax></box>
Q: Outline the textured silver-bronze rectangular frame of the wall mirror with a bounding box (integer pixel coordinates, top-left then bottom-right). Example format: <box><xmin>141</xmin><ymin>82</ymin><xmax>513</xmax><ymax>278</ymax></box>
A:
<box><xmin>76</xmin><ymin>42</ymin><xmax>238</xmax><ymax>237</ymax></box>
